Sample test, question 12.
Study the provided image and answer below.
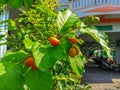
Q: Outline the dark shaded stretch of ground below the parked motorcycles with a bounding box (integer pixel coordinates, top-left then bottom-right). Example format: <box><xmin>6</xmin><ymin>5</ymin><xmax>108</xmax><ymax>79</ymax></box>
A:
<box><xmin>81</xmin><ymin>60</ymin><xmax>120</xmax><ymax>84</ymax></box>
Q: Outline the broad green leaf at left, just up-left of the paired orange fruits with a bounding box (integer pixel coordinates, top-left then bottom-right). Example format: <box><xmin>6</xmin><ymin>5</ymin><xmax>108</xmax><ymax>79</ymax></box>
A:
<box><xmin>2</xmin><ymin>50</ymin><xmax>28</xmax><ymax>63</ymax></box>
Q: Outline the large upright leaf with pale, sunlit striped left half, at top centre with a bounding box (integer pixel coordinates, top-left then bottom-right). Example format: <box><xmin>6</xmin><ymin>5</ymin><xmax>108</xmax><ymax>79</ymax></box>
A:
<box><xmin>57</xmin><ymin>9</ymin><xmax>80</xmax><ymax>33</ymax></box>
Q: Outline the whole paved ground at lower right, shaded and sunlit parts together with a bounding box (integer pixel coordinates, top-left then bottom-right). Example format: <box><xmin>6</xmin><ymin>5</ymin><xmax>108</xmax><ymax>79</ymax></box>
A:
<box><xmin>82</xmin><ymin>60</ymin><xmax>120</xmax><ymax>90</ymax></box>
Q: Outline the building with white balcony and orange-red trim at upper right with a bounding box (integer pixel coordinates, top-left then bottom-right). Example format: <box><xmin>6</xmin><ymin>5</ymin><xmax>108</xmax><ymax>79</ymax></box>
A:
<box><xmin>60</xmin><ymin>0</ymin><xmax>120</xmax><ymax>63</ymax></box>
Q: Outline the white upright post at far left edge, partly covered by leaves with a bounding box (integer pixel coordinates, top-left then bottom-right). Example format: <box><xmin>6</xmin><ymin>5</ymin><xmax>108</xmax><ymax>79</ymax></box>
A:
<box><xmin>0</xmin><ymin>8</ymin><xmax>9</xmax><ymax>59</ymax></box>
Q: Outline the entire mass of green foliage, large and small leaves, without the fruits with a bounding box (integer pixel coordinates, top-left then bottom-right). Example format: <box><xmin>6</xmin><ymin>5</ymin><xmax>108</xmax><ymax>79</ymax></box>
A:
<box><xmin>0</xmin><ymin>0</ymin><xmax>112</xmax><ymax>90</ymax></box>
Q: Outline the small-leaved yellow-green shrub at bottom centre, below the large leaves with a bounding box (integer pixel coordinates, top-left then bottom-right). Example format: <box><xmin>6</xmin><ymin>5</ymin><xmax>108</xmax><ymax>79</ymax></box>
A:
<box><xmin>52</xmin><ymin>58</ymin><xmax>91</xmax><ymax>90</ymax></box>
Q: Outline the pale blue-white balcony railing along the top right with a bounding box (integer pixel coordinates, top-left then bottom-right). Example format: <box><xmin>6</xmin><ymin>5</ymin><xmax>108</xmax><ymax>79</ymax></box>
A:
<box><xmin>69</xmin><ymin>0</ymin><xmax>120</xmax><ymax>10</ymax></box>
